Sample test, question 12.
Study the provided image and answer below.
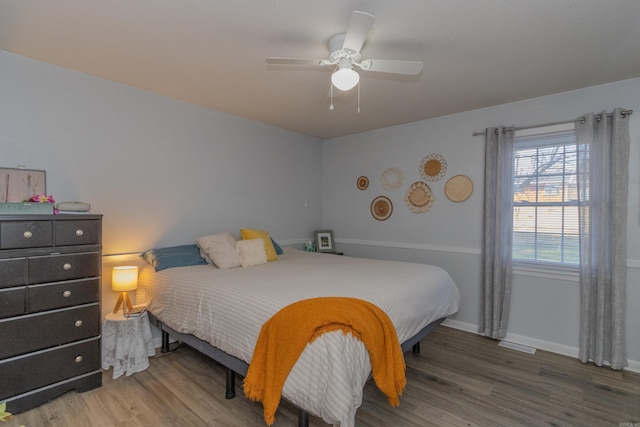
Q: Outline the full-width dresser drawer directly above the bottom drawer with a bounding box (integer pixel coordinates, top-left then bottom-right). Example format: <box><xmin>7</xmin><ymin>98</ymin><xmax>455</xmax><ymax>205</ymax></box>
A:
<box><xmin>0</xmin><ymin>303</ymin><xmax>100</xmax><ymax>367</ymax></box>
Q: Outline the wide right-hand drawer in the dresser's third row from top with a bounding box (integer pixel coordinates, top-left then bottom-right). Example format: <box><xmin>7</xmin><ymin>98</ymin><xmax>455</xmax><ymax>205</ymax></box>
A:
<box><xmin>27</xmin><ymin>277</ymin><xmax>100</xmax><ymax>313</ymax></box>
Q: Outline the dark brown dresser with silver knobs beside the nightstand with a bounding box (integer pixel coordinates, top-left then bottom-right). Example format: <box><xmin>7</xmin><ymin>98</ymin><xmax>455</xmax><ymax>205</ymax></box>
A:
<box><xmin>0</xmin><ymin>214</ymin><xmax>102</xmax><ymax>413</ymax></box>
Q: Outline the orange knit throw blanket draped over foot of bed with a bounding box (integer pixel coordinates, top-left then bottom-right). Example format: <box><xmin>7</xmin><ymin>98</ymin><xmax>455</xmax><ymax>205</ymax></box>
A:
<box><xmin>244</xmin><ymin>297</ymin><xmax>406</xmax><ymax>425</ymax></box>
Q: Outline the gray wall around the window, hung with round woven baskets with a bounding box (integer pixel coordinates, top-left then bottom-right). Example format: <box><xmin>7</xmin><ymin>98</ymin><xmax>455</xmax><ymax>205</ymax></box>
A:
<box><xmin>322</xmin><ymin>79</ymin><xmax>640</xmax><ymax>370</ymax></box>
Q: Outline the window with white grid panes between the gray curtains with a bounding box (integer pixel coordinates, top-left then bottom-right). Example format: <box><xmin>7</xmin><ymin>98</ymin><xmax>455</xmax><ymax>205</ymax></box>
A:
<box><xmin>512</xmin><ymin>125</ymin><xmax>579</xmax><ymax>268</ymax></box>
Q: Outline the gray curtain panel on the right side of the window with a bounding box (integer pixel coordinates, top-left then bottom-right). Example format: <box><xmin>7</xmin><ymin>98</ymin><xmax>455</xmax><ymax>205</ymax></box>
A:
<box><xmin>576</xmin><ymin>109</ymin><xmax>629</xmax><ymax>369</ymax></box>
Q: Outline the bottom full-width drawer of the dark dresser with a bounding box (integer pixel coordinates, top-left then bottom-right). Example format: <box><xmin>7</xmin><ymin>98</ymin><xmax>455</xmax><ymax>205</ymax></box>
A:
<box><xmin>0</xmin><ymin>338</ymin><xmax>100</xmax><ymax>401</ymax></box>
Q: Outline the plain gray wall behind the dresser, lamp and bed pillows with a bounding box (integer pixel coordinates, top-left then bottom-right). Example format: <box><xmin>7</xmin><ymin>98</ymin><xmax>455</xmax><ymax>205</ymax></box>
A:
<box><xmin>0</xmin><ymin>51</ymin><xmax>322</xmax><ymax>313</ymax></box>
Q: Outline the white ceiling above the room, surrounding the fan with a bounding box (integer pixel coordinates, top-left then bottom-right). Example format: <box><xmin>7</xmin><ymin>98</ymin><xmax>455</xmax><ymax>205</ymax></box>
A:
<box><xmin>0</xmin><ymin>0</ymin><xmax>640</xmax><ymax>138</ymax></box>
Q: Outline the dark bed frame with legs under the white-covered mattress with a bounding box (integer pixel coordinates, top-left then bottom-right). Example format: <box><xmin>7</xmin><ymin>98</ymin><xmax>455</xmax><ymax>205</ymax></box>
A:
<box><xmin>149</xmin><ymin>313</ymin><xmax>445</xmax><ymax>427</ymax></box>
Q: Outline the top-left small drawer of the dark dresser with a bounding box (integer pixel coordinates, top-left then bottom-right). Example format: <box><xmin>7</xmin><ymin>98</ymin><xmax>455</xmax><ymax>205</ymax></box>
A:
<box><xmin>0</xmin><ymin>221</ymin><xmax>53</xmax><ymax>249</ymax></box>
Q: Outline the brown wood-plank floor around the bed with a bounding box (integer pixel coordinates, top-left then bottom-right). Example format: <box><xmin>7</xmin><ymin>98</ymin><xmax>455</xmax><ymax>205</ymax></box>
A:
<box><xmin>2</xmin><ymin>326</ymin><xmax>640</xmax><ymax>427</ymax></box>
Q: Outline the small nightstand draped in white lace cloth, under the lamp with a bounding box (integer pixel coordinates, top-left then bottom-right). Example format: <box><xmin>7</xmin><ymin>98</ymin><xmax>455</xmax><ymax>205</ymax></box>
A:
<box><xmin>102</xmin><ymin>312</ymin><xmax>156</xmax><ymax>380</ymax></box>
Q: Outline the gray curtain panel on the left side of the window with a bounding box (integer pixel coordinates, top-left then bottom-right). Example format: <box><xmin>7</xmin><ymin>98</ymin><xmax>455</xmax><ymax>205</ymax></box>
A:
<box><xmin>479</xmin><ymin>127</ymin><xmax>515</xmax><ymax>339</ymax></box>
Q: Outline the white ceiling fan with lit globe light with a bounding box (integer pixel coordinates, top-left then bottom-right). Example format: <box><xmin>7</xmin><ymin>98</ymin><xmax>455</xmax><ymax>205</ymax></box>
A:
<box><xmin>267</xmin><ymin>11</ymin><xmax>424</xmax><ymax>91</ymax></box>
